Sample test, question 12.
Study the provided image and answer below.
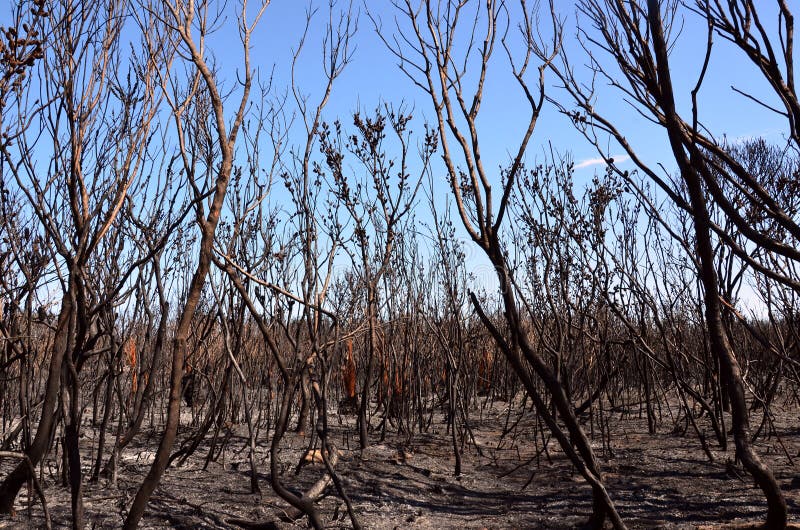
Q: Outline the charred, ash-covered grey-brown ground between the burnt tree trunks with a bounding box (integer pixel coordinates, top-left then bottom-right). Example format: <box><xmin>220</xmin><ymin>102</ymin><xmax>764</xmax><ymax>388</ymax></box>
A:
<box><xmin>0</xmin><ymin>394</ymin><xmax>800</xmax><ymax>530</ymax></box>
